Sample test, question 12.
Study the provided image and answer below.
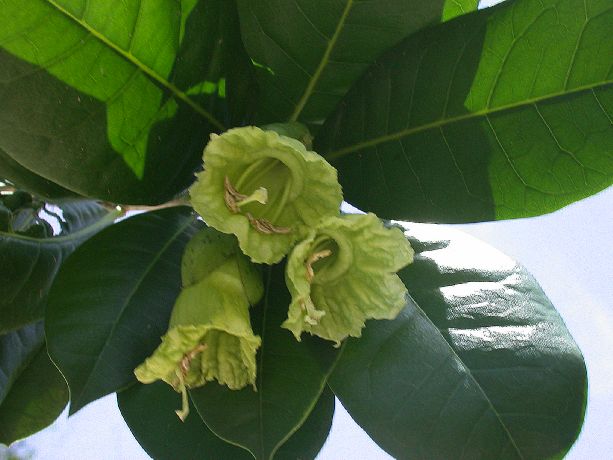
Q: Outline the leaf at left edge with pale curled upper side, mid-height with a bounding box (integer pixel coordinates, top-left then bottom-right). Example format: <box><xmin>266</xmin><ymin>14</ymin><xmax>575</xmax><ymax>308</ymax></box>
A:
<box><xmin>0</xmin><ymin>201</ymin><xmax>120</xmax><ymax>333</ymax></box>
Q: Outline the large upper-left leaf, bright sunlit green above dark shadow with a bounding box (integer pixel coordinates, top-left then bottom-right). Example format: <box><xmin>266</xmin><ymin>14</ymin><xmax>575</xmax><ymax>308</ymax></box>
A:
<box><xmin>0</xmin><ymin>0</ymin><xmax>244</xmax><ymax>203</ymax></box>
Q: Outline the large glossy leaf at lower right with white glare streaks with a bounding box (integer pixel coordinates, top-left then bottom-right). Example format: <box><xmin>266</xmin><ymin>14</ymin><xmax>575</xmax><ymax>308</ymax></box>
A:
<box><xmin>329</xmin><ymin>224</ymin><xmax>587</xmax><ymax>459</ymax></box>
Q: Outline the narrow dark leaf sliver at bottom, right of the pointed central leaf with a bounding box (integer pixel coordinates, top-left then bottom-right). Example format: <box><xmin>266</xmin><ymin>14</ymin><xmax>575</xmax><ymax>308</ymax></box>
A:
<box><xmin>274</xmin><ymin>386</ymin><xmax>334</xmax><ymax>460</ymax></box>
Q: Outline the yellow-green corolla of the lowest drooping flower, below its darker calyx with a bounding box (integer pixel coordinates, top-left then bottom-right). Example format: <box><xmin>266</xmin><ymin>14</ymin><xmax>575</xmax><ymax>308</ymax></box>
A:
<box><xmin>135</xmin><ymin>271</ymin><xmax>261</xmax><ymax>391</ymax></box>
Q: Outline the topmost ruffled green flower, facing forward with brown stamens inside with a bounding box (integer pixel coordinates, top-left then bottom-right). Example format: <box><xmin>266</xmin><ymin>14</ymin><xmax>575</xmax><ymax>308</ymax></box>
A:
<box><xmin>190</xmin><ymin>126</ymin><xmax>342</xmax><ymax>264</ymax></box>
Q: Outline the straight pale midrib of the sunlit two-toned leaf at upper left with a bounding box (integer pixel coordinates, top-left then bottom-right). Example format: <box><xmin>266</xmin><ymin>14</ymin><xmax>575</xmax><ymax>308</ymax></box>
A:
<box><xmin>44</xmin><ymin>0</ymin><xmax>226</xmax><ymax>131</ymax></box>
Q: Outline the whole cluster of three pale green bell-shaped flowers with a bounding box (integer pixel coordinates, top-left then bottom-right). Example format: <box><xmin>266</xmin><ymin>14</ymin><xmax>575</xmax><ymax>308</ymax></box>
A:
<box><xmin>135</xmin><ymin>124</ymin><xmax>413</xmax><ymax>418</ymax></box>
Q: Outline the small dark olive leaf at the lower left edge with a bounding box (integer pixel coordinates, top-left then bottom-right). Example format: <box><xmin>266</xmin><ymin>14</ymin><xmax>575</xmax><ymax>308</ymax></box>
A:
<box><xmin>0</xmin><ymin>323</ymin><xmax>68</xmax><ymax>445</ymax></box>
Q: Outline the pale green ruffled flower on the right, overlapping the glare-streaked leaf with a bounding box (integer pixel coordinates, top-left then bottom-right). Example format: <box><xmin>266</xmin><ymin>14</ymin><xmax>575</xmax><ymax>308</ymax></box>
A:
<box><xmin>282</xmin><ymin>214</ymin><xmax>413</xmax><ymax>345</ymax></box>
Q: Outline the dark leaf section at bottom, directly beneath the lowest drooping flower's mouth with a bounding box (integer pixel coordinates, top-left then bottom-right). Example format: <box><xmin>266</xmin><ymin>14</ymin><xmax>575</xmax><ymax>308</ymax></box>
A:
<box><xmin>117</xmin><ymin>382</ymin><xmax>253</xmax><ymax>460</ymax></box>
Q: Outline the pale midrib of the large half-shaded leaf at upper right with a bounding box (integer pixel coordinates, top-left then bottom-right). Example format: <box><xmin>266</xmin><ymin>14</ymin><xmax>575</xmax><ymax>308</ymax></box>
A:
<box><xmin>323</xmin><ymin>80</ymin><xmax>613</xmax><ymax>161</ymax></box>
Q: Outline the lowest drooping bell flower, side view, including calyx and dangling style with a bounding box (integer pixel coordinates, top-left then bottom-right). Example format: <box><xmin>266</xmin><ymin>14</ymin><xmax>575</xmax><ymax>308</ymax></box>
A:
<box><xmin>134</xmin><ymin>229</ymin><xmax>263</xmax><ymax>420</ymax></box>
